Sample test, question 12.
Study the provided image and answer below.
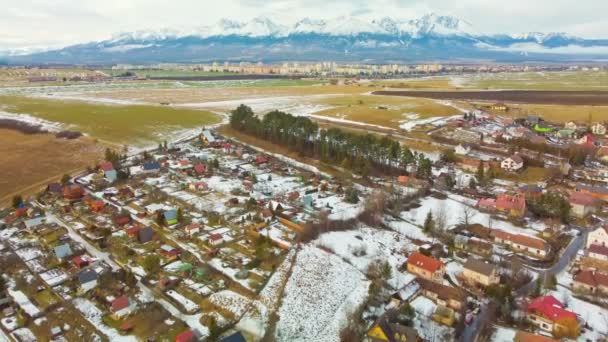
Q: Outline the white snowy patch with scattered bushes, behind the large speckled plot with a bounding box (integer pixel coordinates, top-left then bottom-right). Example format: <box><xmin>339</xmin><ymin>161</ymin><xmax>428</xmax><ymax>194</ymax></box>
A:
<box><xmin>314</xmin><ymin>227</ymin><xmax>417</xmax><ymax>289</ymax></box>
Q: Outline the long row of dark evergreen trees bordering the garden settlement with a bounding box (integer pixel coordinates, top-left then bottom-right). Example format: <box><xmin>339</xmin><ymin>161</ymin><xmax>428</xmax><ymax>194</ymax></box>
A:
<box><xmin>230</xmin><ymin>105</ymin><xmax>432</xmax><ymax>179</ymax></box>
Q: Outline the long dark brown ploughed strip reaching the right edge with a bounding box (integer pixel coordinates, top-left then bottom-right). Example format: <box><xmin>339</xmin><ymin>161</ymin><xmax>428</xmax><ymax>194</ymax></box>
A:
<box><xmin>372</xmin><ymin>90</ymin><xmax>608</xmax><ymax>106</ymax></box>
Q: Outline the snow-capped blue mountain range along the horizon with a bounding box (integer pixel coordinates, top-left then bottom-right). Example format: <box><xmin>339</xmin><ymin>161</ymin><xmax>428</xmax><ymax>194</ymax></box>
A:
<box><xmin>0</xmin><ymin>14</ymin><xmax>608</xmax><ymax>64</ymax></box>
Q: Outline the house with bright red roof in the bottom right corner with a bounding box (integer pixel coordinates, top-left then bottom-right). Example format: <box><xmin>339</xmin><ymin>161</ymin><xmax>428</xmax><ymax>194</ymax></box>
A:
<box><xmin>526</xmin><ymin>296</ymin><xmax>579</xmax><ymax>337</ymax></box>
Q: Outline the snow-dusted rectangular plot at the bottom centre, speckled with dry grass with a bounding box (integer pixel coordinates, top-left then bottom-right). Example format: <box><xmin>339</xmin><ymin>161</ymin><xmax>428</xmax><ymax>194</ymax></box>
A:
<box><xmin>275</xmin><ymin>246</ymin><xmax>369</xmax><ymax>341</ymax></box>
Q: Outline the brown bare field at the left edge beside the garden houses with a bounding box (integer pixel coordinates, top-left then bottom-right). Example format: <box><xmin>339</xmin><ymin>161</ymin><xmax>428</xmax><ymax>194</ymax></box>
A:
<box><xmin>0</xmin><ymin>129</ymin><xmax>105</xmax><ymax>204</ymax></box>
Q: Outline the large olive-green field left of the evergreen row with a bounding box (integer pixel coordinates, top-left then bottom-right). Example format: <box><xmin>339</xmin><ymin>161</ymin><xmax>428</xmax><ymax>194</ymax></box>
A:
<box><xmin>0</xmin><ymin>96</ymin><xmax>220</xmax><ymax>146</ymax></box>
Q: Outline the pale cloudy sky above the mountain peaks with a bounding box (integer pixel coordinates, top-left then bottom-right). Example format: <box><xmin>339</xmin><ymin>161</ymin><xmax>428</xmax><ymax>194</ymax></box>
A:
<box><xmin>0</xmin><ymin>0</ymin><xmax>608</xmax><ymax>50</ymax></box>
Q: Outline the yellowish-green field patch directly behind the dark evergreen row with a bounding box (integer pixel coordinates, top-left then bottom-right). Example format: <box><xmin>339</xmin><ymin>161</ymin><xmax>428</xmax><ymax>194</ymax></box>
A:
<box><xmin>315</xmin><ymin>94</ymin><xmax>459</xmax><ymax>128</ymax></box>
